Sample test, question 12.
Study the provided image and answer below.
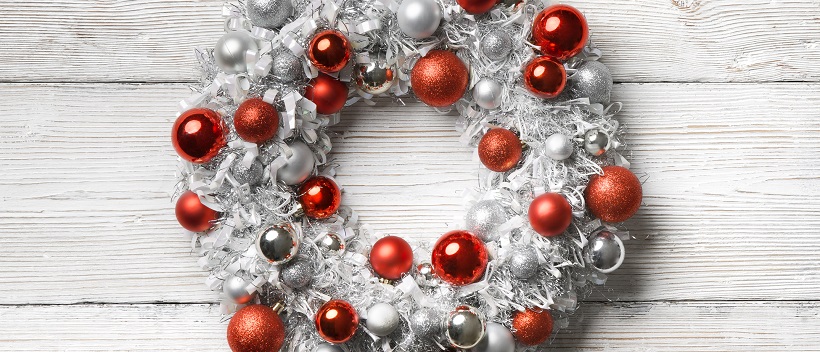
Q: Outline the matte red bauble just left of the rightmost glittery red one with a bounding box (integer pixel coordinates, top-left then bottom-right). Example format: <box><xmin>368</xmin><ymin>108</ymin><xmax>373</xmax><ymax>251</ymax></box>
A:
<box><xmin>529</xmin><ymin>193</ymin><xmax>572</xmax><ymax>237</ymax></box>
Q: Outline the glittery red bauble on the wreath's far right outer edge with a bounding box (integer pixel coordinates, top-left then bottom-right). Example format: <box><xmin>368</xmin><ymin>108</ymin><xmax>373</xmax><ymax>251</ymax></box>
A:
<box><xmin>584</xmin><ymin>166</ymin><xmax>643</xmax><ymax>222</ymax></box>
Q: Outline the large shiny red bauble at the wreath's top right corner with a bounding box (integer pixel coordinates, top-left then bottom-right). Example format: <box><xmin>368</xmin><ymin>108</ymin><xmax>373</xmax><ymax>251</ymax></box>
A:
<box><xmin>532</xmin><ymin>5</ymin><xmax>589</xmax><ymax>60</ymax></box>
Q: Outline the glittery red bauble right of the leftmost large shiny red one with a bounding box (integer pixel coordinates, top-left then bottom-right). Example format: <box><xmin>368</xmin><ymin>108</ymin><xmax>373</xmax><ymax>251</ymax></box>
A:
<box><xmin>233</xmin><ymin>98</ymin><xmax>279</xmax><ymax>143</ymax></box>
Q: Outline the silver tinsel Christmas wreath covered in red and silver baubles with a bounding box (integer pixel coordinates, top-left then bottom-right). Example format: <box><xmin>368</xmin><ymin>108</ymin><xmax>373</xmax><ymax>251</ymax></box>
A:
<box><xmin>172</xmin><ymin>0</ymin><xmax>642</xmax><ymax>352</ymax></box>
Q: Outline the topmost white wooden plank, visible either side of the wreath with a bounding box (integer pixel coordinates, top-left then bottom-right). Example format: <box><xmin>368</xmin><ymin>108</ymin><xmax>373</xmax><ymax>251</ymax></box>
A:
<box><xmin>0</xmin><ymin>0</ymin><xmax>820</xmax><ymax>82</ymax></box>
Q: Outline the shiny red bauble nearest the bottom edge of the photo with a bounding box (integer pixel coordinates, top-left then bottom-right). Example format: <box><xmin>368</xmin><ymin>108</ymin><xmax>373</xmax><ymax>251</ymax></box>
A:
<box><xmin>316</xmin><ymin>299</ymin><xmax>359</xmax><ymax>343</ymax></box>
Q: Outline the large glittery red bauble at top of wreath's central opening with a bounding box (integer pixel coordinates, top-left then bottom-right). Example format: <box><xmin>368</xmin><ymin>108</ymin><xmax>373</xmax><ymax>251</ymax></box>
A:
<box><xmin>410</xmin><ymin>50</ymin><xmax>470</xmax><ymax>107</ymax></box>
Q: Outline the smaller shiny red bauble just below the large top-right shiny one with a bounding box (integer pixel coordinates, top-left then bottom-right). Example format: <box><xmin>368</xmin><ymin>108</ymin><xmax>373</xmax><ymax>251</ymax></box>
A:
<box><xmin>524</xmin><ymin>56</ymin><xmax>567</xmax><ymax>99</ymax></box>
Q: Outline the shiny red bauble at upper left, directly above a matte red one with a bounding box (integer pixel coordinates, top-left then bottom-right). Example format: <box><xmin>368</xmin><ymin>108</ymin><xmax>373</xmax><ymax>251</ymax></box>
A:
<box><xmin>308</xmin><ymin>29</ymin><xmax>353</xmax><ymax>73</ymax></box>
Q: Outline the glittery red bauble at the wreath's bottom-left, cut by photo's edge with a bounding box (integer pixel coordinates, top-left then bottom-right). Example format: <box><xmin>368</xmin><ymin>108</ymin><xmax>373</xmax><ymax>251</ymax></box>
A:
<box><xmin>228</xmin><ymin>304</ymin><xmax>285</xmax><ymax>352</ymax></box>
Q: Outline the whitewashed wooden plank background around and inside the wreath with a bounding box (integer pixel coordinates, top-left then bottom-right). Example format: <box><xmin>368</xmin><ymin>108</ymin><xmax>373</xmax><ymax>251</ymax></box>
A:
<box><xmin>0</xmin><ymin>0</ymin><xmax>820</xmax><ymax>352</ymax></box>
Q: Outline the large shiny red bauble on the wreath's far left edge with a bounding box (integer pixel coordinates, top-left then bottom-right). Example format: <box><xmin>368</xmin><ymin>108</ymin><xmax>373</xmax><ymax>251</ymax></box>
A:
<box><xmin>171</xmin><ymin>108</ymin><xmax>226</xmax><ymax>164</ymax></box>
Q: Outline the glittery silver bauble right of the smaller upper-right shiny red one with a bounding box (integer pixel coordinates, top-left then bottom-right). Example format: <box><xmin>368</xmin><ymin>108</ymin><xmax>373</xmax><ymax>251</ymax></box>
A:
<box><xmin>567</xmin><ymin>61</ymin><xmax>612</xmax><ymax>104</ymax></box>
